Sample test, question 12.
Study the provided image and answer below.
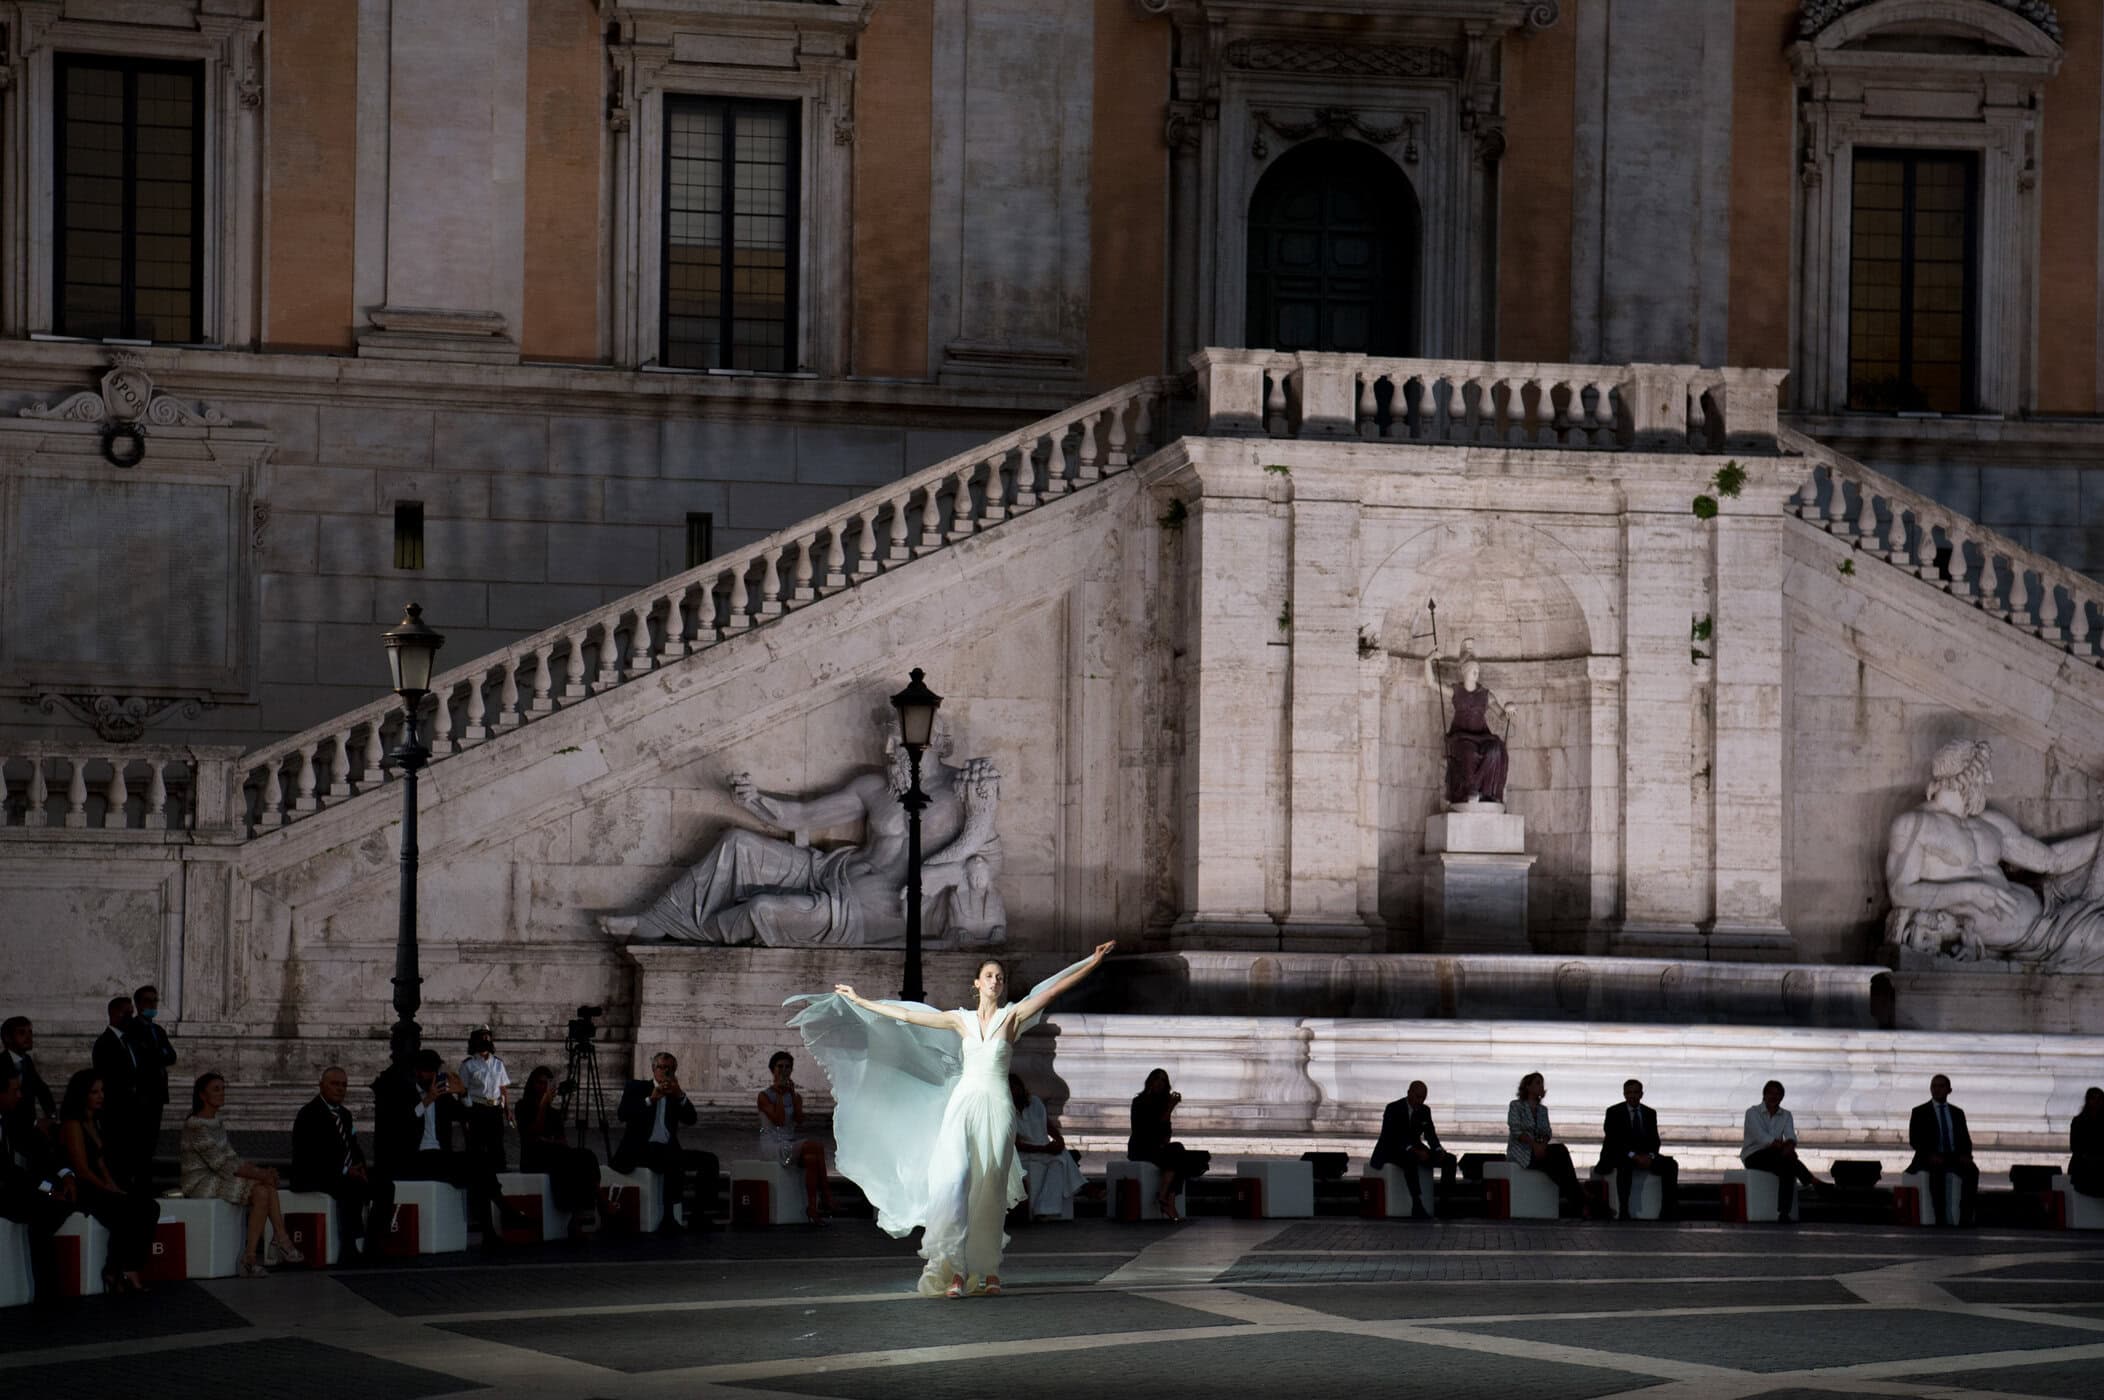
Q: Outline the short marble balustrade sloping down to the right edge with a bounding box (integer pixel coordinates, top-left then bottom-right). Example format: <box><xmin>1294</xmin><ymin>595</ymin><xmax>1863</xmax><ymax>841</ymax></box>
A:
<box><xmin>1780</xmin><ymin>429</ymin><xmax>2104</xmax><ymax>667</ymax></box>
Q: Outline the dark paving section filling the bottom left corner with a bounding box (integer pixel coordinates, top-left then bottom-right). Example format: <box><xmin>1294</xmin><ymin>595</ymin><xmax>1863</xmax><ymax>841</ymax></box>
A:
<box><xmin>0</xmin><ymin>1337</ymin><xmax>484</xmax><ymax>1400</ymax></box>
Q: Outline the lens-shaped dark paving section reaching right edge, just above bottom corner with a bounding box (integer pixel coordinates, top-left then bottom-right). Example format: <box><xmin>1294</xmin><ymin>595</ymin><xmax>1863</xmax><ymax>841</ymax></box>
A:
<box><xmin>1460</xmin><ymin>1307</ymin><xmax>2104</xmax><ymax>1379</ymax></box>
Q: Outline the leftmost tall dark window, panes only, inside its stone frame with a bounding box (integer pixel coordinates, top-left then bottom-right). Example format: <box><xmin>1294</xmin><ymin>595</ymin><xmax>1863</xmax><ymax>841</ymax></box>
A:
<box><xmin>53</xmin><ymin>55</ymin><xmax>204</xmax><ymax>341</ymax></box>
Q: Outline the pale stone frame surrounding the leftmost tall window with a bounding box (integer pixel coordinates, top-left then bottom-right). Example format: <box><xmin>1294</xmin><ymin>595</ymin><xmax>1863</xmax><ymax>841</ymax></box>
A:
<box><xmin>0</xmin><ymin>0</ymin><xmax>263</xmax><ymax>345</ymax></box>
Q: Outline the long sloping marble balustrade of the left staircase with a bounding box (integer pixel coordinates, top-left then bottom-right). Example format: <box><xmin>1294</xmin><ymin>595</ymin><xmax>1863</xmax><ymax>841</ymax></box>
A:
<box><xmin>225</xmin><ymin>377</ymin><xmax>1176</xmax><ymax>834</ymax></box>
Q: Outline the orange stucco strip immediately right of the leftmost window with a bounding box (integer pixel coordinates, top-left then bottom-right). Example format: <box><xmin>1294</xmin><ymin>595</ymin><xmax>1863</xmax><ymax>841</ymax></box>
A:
<box><xmin>263</xmin><ymin>0</ymin><xmax>358</xmax><ymax>349</ymax></box>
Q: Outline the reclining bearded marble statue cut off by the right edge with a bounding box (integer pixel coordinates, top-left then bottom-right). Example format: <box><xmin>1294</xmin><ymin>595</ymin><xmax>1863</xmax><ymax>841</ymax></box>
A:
<box><xmin>1885</xmin><ymin>739</ymin><xmax>2104</xmax><ymax>973</ymax></box>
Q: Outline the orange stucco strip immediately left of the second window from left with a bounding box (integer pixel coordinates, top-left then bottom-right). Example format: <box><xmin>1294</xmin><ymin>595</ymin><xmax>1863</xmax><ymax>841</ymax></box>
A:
<box><xmin>518</xmin><ymin>0</ymin><xmax>606</xmax><ymax>360</ymax></box>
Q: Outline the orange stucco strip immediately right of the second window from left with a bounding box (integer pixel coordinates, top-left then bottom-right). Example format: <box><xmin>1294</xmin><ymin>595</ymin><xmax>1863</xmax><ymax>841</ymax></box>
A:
<box><xmin>854</xmin><ymin>0</ymin><xmax>934</xmax><ymax>379</ymax></box>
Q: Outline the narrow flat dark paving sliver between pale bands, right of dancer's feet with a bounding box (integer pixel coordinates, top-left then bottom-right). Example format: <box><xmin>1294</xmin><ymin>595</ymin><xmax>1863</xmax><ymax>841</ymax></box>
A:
<box><xmin>1241</xmin><ymin>1278</ymin><xmax>1856</xmax><ymax>1322</ymax></box>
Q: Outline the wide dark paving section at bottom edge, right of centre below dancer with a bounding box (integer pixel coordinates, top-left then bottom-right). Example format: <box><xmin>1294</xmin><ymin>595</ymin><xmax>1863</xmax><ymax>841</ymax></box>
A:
<box><xmin>739</xmin><ymin>1309</ymin><xmax>1656</xmax><ymax>1400</ymax></box>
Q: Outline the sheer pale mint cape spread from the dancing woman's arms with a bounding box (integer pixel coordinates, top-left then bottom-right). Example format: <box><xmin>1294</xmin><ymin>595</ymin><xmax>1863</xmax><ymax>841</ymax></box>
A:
<box><xmin>783</xmin><ymin>958</ymin><xmax>1088</xmax><ymax>1236</ymax></box>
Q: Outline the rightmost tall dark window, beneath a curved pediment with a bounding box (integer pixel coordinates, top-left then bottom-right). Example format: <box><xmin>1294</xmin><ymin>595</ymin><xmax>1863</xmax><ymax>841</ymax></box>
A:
<box><xmin>1847</xmin><ymin>149</ymin><xmax>1980</xmax><ymax>413</ymax></box>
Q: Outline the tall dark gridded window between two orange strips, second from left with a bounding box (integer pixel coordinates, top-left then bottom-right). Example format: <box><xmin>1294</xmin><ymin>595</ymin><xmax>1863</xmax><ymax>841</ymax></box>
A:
<box><xmin>663</xmin><ymin>97</ymin><xmax>797</xmax><ymax>371</ymax></box>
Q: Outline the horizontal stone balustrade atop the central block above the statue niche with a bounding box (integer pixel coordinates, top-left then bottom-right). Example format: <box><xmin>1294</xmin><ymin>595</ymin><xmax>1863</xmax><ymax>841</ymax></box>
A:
<box><xmin>1191</xmin><ymin>349</ymin><xmax>1784</xmax><ymax>457</ymax></box>
